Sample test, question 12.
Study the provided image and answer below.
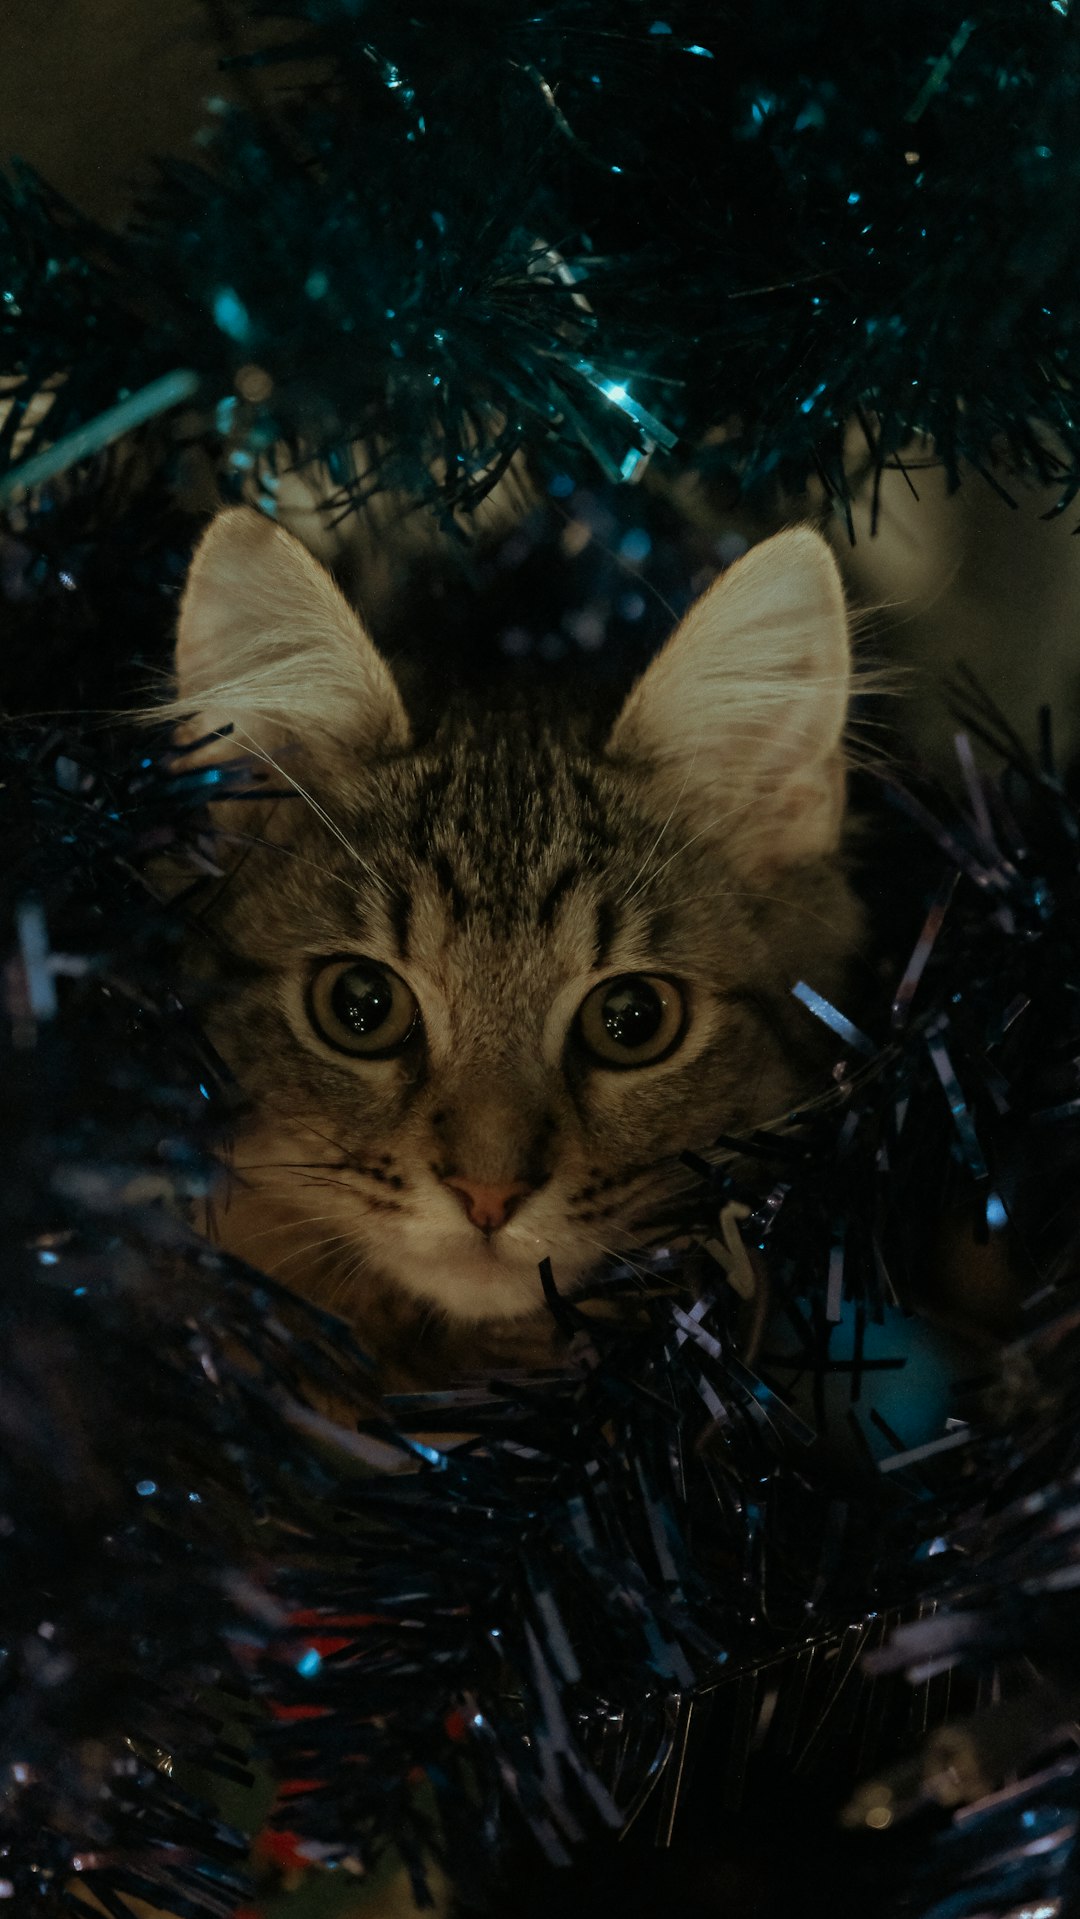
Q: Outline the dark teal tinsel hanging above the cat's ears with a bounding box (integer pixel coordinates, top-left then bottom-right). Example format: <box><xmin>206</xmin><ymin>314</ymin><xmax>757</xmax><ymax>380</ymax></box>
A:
<box><xmin>0</xmin><ymin>0</ymin><xmax>1080</xmax><ymax>507</ymax></box>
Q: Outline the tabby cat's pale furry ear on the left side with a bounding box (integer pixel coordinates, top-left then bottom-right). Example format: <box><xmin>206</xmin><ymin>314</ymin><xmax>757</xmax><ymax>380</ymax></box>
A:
<box><xmin>171</xmin><ymin>507</ymin><xmax>409</xmax><ymax>752</ymax></box>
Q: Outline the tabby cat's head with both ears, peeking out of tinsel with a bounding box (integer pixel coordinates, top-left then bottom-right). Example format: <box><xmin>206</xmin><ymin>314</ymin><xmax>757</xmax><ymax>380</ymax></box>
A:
<box><xmin>168</xmin><ymin>510</ymin><xmax>856</xmax><ymax>1320</ymax></box>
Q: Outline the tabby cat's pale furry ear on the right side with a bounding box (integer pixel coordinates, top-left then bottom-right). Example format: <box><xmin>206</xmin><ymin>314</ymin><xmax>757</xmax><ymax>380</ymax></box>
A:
<box><xmin>608</xmin><ymin>526</ymin><xmax>852</xmax><ymax>869</ymax></box>
